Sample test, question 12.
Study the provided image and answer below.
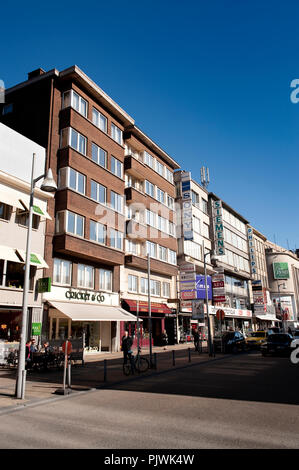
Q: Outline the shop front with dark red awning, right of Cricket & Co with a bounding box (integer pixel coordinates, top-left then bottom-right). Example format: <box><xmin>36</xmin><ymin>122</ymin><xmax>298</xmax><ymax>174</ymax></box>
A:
<box><xmin>121</xmin><ymin>299</ymin><xmax>176</xmax><ymax>347</ymax></box>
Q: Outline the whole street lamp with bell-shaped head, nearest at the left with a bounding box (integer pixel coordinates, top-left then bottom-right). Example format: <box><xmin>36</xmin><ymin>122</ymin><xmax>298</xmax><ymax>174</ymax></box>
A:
<box><xmin>16</xmin><ymin>153</ymin><xmax>57</xmax><ymax>399</ymax></box>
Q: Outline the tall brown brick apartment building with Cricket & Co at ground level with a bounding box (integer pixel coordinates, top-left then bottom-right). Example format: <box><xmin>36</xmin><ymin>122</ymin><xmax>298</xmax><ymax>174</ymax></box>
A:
<box><xmin>1</xmin><ymin>66</ymin><xmax>179</xmax><ymax>351</ymax></box>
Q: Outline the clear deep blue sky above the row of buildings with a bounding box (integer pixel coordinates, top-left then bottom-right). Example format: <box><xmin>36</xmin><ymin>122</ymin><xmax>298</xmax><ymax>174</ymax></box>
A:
<box><xmin>0</xmin><ymin>0</ymin><xmax>299</xmax><ymax>249</ymax></box>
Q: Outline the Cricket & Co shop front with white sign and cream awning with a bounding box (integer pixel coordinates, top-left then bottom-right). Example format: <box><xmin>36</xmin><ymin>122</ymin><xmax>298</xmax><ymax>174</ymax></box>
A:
<box><xmin>43</xmin><ymin>286</ymin><xmax>136</xmax><ymax>352</ymax></box>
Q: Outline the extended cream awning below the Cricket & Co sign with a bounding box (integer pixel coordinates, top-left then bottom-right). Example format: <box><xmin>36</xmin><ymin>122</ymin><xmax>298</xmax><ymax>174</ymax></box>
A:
<box><xmin>48</xmin><ymin>300</ymin><xmax>142</xmax><ymax>321</ymax></box>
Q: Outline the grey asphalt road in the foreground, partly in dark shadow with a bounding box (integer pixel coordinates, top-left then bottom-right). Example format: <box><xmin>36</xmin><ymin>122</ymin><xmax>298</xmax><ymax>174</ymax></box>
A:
<box><xmin>0</xmin><ymin>353</ymin><xmax>299</xmax><ymax>449</ymax></box>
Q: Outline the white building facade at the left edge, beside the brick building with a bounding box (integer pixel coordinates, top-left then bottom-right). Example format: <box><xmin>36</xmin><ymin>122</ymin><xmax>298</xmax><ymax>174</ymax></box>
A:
<box><xmin>0</xmin><ymin>124</ymin><xmax>53</xmax><ymax>342</ymax></box>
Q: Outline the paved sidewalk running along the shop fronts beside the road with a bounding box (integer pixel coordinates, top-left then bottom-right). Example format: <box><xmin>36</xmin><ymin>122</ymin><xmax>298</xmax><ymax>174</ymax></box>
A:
<box><xmin>0</xmin><ymin>343</ymin><xmax>223</xmax><ymax>414</ymax></box>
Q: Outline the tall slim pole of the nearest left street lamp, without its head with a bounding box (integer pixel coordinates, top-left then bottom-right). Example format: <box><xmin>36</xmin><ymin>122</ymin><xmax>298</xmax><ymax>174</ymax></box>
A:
<box><xmin>16</xmin><ymin>153</ymin><xmax>35</xmax><ymax>399</ymax></box>
